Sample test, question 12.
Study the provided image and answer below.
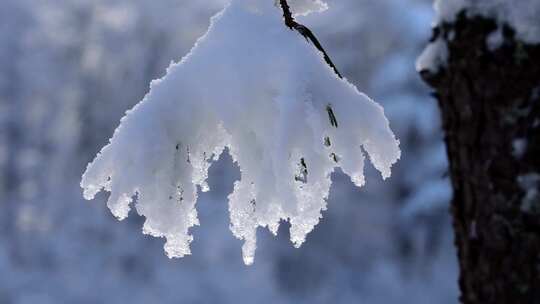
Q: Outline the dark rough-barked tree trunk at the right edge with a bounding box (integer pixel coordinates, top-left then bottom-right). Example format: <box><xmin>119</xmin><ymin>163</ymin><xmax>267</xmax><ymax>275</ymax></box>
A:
<box><xmin>421</xmin><ymin>13</ymin><xmax>540</xmax><ymax>304</ymax></box>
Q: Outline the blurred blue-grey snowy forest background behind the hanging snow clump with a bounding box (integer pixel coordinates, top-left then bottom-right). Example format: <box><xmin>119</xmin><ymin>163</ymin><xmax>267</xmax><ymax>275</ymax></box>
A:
<box><xmin>0</xmin><ymin>0</ymin><xmax>458</xmax><ymax>304</ymax></box>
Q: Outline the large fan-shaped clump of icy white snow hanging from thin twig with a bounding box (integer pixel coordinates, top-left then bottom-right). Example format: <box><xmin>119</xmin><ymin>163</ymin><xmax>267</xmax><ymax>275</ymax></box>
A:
<box><xmin>81</xmin><ymin>0</ymin><xmax>400</xmax><ymax>264</ymax></box>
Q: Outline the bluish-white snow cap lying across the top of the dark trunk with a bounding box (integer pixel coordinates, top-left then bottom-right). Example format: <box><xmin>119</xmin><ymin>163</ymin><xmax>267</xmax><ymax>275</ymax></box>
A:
<box><xmin>434</xmin><ymin>0</ymin><xmax>540</xmax><ymax>44</ymax></box>
